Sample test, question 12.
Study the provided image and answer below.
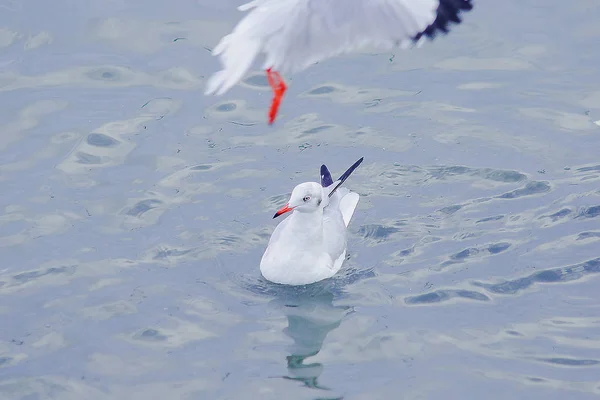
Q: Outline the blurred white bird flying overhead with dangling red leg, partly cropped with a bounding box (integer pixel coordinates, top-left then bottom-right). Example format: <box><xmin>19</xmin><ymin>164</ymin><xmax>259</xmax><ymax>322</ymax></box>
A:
<box><xmin>205</xmin><ymin>0</ymin><xmax>473</xmax><ymax>124</ymax></box>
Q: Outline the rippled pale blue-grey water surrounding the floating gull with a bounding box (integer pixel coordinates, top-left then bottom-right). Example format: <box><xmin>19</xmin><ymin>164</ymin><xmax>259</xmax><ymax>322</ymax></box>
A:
<box><xmin>0</xmin><ymin>0</ymin><xmax>600</xmax><ymax>400</ymax></box>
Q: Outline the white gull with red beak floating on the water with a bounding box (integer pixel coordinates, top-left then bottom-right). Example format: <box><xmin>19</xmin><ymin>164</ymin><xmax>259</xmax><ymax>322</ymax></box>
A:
<box><xmin>260</xmin><ymin>158</ymin><xmax>363</xmax><ymax>285</ymax></box>
